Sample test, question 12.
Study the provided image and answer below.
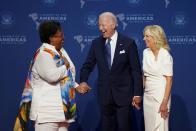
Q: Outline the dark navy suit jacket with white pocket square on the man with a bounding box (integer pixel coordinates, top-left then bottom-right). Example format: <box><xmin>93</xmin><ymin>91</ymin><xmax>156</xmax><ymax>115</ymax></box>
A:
<box><xmin>80</xmin><ymin>33</ymin><xmax>143</xmax><ymax>106</ymax></box>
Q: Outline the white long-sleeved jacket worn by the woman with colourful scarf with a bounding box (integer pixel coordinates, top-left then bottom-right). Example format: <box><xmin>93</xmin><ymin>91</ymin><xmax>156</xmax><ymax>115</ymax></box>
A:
<box><xmin>30</xmin><ymin>43</ymin><xmax>78</xmax><ymax>123</ymax></box>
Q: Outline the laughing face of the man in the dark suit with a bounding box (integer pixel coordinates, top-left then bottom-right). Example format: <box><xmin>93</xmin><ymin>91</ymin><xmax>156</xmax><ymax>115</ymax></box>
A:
<box><xmin>99</xmin><ymin>16</ymin><xmax>116</xmax><ymax>39</ymax></box>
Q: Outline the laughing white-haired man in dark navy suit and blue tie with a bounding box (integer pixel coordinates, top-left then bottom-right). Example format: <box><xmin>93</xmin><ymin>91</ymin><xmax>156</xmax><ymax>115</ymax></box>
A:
<box><xmin>80</xmin><ymin>12</ymin><xmax>143</xmax><ymax>131</ymax></box>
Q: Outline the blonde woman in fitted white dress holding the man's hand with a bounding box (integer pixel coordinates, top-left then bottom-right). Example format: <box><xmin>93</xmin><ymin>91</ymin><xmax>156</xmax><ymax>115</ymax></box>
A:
<box><xmin>143</xmin><ymin>25</ymin><xmax>173</xmax><ymax>131</ymax></box>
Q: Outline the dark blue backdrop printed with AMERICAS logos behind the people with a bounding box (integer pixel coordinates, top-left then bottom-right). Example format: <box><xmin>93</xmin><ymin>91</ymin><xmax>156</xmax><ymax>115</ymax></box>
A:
<box><xmin>0</xmin><ymin>0</ymin><xmax>196</xmax><ymax>131</ymax></box>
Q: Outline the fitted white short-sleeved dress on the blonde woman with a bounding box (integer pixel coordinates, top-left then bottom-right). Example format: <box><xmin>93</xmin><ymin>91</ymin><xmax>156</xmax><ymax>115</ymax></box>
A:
<box><xmin>143</xmin><ymin>48</ymin><xmax>173</xmax><ymax>131</ymax></box>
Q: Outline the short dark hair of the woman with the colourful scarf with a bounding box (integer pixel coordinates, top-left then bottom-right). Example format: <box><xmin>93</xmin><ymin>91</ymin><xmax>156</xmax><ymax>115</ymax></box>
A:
<box><xmin>39</xmin><ymin>21</ymin><xmax>61</xmax><ymax>44</ymax></box>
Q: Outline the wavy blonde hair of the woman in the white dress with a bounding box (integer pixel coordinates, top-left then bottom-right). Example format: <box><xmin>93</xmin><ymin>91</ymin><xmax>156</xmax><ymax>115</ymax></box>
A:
<box><xmin>143</xmin><ymin>25</ymin><xmax>170</xmax><ymax>51</ymax></box>
